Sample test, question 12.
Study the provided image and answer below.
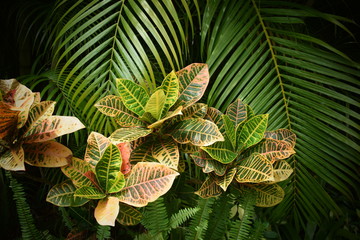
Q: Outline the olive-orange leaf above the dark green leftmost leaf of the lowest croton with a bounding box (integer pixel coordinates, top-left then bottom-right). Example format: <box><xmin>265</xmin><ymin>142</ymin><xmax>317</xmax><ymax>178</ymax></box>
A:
<box><xmin>61</xmin><ymin>157</ymin><xmax>93</xmax><ymax>187</ymax></box>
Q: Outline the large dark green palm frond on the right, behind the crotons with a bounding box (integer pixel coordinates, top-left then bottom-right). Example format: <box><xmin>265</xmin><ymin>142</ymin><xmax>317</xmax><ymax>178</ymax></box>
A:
<box><xmin>201</xmin><ymin>1</ymin><xmax>360</xmax><ymax>224</ymax></box>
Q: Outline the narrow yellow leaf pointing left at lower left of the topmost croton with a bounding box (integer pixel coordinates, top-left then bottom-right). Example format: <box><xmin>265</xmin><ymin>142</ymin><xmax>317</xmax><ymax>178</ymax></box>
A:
<box><xmin>109</xmin><ymin>128</ymin><xmax>152</xmax><ymax>144</ymax></box>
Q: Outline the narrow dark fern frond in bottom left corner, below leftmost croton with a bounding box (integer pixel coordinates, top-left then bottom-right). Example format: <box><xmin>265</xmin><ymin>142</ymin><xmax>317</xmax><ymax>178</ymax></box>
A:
<box><xmin>6</xmin><ymin>171</ymin><xmax>44</xmax><ymax>240</ymax></box>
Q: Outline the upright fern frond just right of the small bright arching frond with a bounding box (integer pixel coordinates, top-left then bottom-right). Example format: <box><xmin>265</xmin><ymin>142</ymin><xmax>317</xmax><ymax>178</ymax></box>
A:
<box><xmin>185</xmin><ymin>198</ymin><xmax>215</xmax><ymax>240</ymax></box>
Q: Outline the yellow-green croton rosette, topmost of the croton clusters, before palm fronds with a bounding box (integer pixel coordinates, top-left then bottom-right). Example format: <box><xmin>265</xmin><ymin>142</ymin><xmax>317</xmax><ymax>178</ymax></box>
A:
<box><xmin>95</xmin><ymin>63</ymin><xmax>224</xmax><ymax>170</ymax></box>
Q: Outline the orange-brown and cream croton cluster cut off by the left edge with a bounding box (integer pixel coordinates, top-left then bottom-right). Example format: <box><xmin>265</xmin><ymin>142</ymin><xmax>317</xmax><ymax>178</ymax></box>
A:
<box><xmin>0</xmin><ymin>79</ymin><xmax>84</xmax><ymax>171</ymax></box>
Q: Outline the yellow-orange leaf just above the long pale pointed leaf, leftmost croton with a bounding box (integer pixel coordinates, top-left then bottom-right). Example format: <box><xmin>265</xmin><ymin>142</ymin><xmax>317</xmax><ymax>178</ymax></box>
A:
<box><xmin>24</xmin><ymin>101</ymin><xmax>56</xmax><ymax>131</ymax></box>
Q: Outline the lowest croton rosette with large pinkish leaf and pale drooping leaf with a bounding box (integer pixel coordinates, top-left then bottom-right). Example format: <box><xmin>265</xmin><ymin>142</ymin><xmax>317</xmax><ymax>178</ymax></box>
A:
<box><xmin>47</xmin><ymin>132</ymin><xmax>179</xmax><ymax>226</ymax></box>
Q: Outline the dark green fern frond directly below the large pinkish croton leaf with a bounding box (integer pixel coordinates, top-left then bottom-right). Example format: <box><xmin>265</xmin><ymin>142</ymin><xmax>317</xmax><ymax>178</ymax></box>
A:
<box><xmin>141</xmin><ymin>197</ymin><xmax>170</xmax><ymax>236</ymax></box>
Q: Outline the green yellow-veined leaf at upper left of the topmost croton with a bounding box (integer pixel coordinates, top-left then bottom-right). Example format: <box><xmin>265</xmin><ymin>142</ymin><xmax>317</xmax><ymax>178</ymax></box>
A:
<box><xmin>116</xmin><ymin>79</ymin><xmax>149</xmax><ymax>116</ymax></box>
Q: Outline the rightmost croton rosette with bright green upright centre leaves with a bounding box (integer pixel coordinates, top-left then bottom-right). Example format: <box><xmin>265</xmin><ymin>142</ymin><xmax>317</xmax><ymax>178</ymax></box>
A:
<box><xmin>191</xmin><ymin>99</ymin><xmax>296</xmax><ymax>207</ymax></box>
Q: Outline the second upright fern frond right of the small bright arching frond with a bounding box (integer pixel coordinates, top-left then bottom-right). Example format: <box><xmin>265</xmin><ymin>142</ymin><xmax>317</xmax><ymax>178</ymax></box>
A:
<box><xmin>205</xmin><ymin>195</ymin><xmax>233</xmax><ymax>240</ymax></box>
